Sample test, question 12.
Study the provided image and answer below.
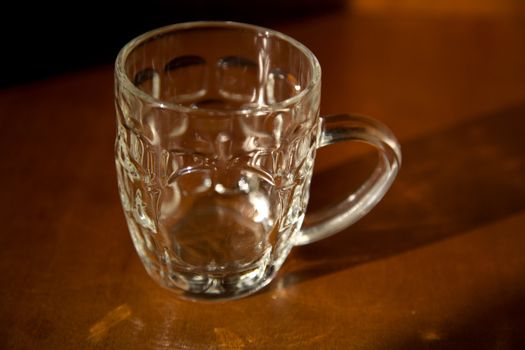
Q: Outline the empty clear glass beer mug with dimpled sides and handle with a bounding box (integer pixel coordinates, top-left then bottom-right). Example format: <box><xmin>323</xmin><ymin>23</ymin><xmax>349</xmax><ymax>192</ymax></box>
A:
<box><xmin>115</xmin><ymin>22</ymin><xmax>401</xmax><ymax>300</ymax></box>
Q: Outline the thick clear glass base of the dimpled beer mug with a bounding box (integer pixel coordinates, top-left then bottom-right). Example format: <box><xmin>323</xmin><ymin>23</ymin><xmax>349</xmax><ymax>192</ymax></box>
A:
<box><xmin>141</xmin><ymin>254</ymin><xmax>279</xmax><ymax>301</ymax></box>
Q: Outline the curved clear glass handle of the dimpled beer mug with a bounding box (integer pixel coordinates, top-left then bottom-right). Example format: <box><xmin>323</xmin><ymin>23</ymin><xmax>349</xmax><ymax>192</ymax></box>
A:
<box><xmin>295</xmin><ymin>114</ymin><xmax>401</xmax><ymax>245</ymax></box>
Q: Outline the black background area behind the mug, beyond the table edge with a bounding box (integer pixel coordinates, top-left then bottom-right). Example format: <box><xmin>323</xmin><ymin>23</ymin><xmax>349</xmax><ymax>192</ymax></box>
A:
<box><xmin>0</xmin><ymin>0</ymin><xmax>345</xmax><ymax>88</ymax></box>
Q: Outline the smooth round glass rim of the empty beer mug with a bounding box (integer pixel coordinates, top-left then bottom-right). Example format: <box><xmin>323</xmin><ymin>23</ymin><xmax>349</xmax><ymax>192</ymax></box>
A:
<box><xmin>115</xmin><ymin>21</ymin><xmax>321</xmax><ymax>114</ymax></box>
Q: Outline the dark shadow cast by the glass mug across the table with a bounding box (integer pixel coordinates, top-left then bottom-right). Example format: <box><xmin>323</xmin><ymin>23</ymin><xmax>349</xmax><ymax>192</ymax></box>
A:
<box><xmin>270</xmin><ymin>104</ymin><xmax>525</xmax><ymax>289</ymax></box>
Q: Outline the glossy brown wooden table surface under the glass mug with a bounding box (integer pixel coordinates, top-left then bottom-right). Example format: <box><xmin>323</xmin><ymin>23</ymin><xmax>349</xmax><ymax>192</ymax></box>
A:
<box><xmin>0</xmin><ymin>1</ymin><xmax>525</xmax><ymax>349</ymax></box>
